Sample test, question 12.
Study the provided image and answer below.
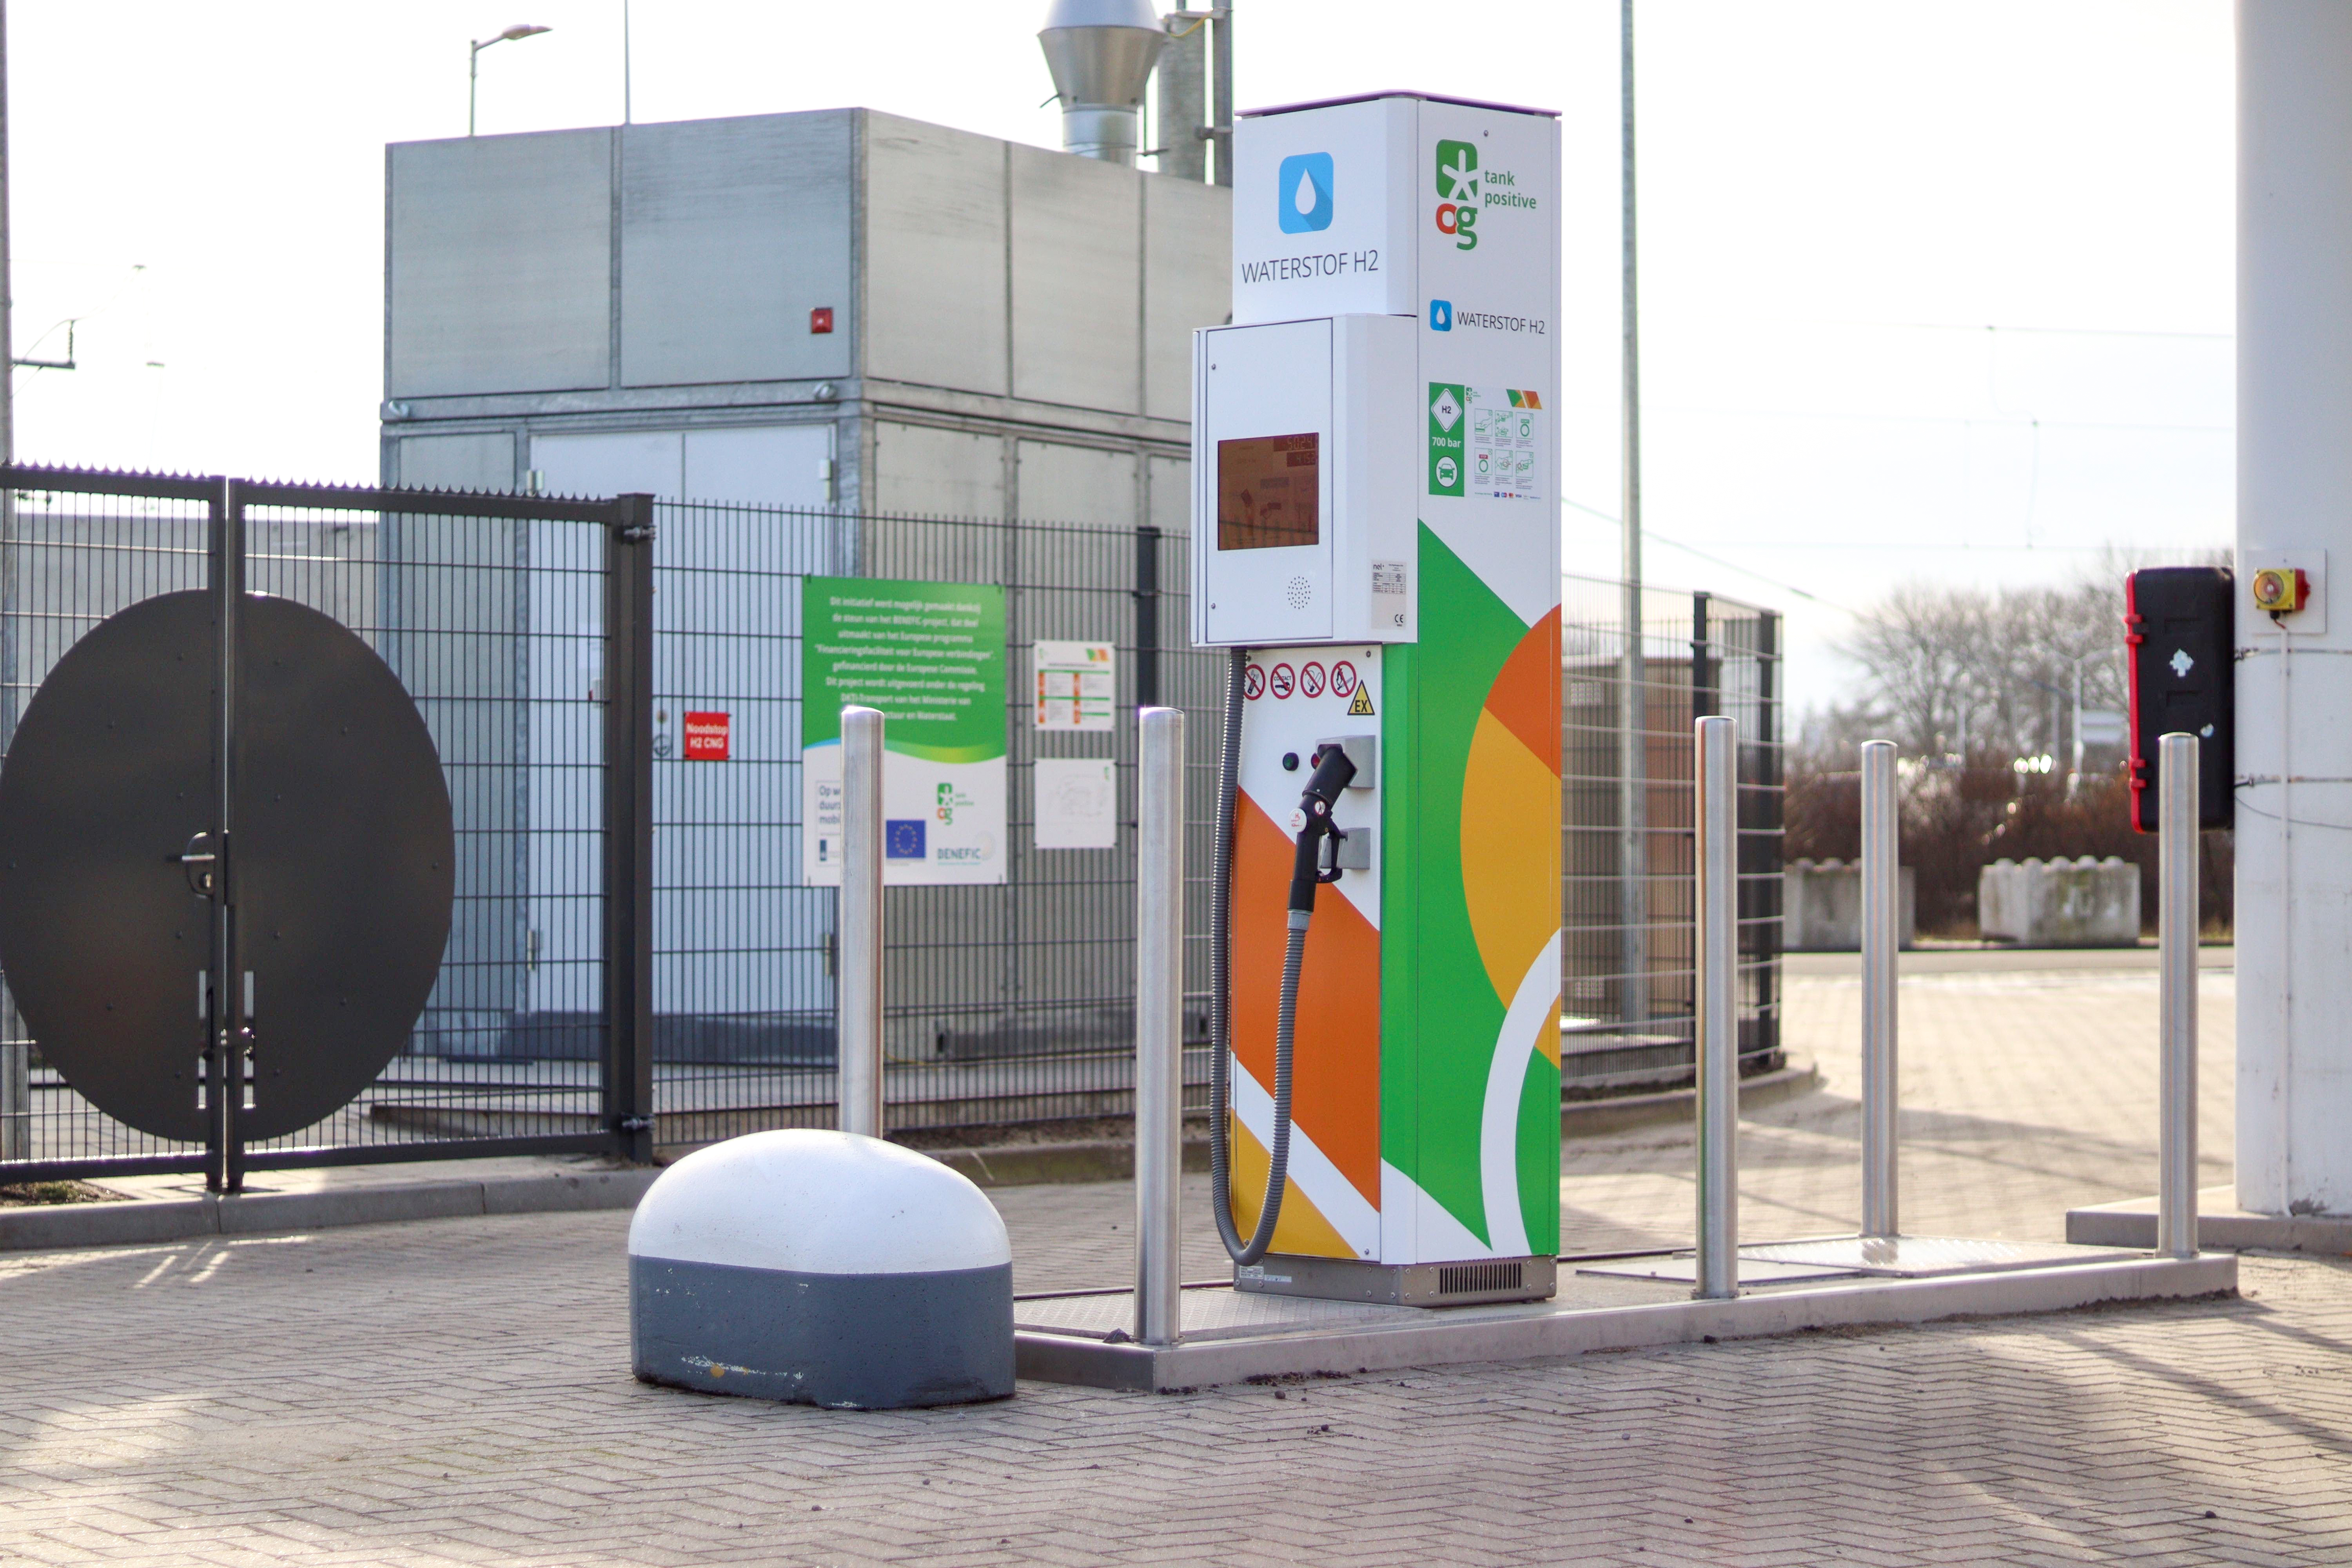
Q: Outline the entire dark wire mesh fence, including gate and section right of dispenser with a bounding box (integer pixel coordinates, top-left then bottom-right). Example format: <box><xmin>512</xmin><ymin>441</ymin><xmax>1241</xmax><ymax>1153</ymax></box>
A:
<box><xmin>0</xmin><ymin>470</ymin><xmax>1780</xmax><ymax>1180</ymax></box>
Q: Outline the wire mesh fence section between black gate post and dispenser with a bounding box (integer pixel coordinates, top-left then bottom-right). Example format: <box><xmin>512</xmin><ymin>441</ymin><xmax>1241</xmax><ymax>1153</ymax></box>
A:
<box><xmin>654</xmin><ymin>503</ymin><xmax>1221</xmax><ymax>1143</ymax></box>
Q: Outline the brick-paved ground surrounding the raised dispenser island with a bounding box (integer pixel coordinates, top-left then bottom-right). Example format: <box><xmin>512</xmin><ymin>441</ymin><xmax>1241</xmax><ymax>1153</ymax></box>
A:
<box><xmin>0</xmin><ymin>976</ymin><xmax>2352</xmax><ymax>1568</ymax></box>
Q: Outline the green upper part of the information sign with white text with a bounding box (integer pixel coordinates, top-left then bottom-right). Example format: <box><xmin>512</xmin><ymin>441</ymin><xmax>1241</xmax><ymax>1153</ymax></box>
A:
<box><xmin>800</xmin><ymin>576</ymin><xmax>1004</xmax><ymax>762</ymax></box>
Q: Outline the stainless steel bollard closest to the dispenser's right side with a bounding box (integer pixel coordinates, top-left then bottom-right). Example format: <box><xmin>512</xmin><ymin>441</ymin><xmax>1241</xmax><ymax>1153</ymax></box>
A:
<box><xmin>1693</xmin><ymin>717</ymin><xmax>1740</xmax><ymax>1300</ymax></box>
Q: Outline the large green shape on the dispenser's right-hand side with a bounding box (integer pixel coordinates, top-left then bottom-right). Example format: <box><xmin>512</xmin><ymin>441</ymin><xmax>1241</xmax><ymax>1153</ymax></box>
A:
<box><xmin>1381</xmin><ymin>526</ymin><xmax>1559</xmax><ymax>1246</ymax></box>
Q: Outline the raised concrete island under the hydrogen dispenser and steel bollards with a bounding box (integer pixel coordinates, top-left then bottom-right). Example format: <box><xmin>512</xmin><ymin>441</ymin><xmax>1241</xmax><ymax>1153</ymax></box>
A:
<box><xmin>1014</xmin><ymin>1248</ymin><xmax>2237</xmax><ymax>1392</ymax></box>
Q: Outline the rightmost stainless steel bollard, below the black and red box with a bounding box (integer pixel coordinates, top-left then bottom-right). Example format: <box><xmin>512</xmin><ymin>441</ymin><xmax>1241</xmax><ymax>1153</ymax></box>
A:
<box><xmin>2157</xmin><ymin>733</ymin><xmax>2199</xmax><ymax>1258</ymax></box>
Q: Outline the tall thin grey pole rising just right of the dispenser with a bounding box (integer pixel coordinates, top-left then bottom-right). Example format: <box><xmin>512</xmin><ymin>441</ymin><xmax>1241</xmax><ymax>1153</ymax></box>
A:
<box><xmin>1618</xmin><ymin>0</ymin><xmax>1649</xmax><ymax>1044</ymax></box>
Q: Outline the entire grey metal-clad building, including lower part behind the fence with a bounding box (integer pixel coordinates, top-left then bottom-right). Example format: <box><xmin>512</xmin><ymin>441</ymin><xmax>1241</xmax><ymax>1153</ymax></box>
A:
<box><xmin>381</xmin><ymin>104</ymin><xmax>1230</xmax><ymax>1060</ymax></box>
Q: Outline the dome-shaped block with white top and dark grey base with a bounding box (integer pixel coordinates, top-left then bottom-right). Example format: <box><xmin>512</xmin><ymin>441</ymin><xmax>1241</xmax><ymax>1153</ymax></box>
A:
<box><xmin>628</xmin><ymin>1129</ymin><xmax>1014</xmax><ymax>1410</ymax></box>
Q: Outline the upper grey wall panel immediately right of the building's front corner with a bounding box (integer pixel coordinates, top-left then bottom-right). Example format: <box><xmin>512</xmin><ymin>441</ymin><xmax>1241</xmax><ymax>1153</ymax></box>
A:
<box><xmin>863</xmin><ymin>111</ymin><xmax>1011</xmax><ymax>395</ymax></box>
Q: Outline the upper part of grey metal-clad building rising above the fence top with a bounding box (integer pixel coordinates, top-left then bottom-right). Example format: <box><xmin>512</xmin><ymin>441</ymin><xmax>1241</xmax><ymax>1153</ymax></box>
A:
<box><xmin>383</xmin><ymin>108</ymin><xmax>1232</xmax><ymax>531</ymax></box>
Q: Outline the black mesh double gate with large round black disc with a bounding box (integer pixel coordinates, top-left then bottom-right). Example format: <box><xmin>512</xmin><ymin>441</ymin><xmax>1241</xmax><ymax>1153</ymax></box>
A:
<box><xmin>0</xmin><ymin>465</ymin><xmax>652</xmax><ymax>1189</ymax></box>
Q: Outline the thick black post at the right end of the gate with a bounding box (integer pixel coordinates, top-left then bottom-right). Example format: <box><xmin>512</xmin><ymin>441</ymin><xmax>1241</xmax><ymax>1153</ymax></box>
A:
<box><xmin>604</xmin><ymin>494</ymin><xmax>654</xmax><ymax>1164</ymax></box>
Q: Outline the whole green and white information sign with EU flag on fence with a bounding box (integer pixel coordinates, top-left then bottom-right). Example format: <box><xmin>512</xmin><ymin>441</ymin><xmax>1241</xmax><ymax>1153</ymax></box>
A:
<box><xmin>800</xmin><ymin>576</ymin><xmax>1007</xmax><ymax>886</ymax></box>
